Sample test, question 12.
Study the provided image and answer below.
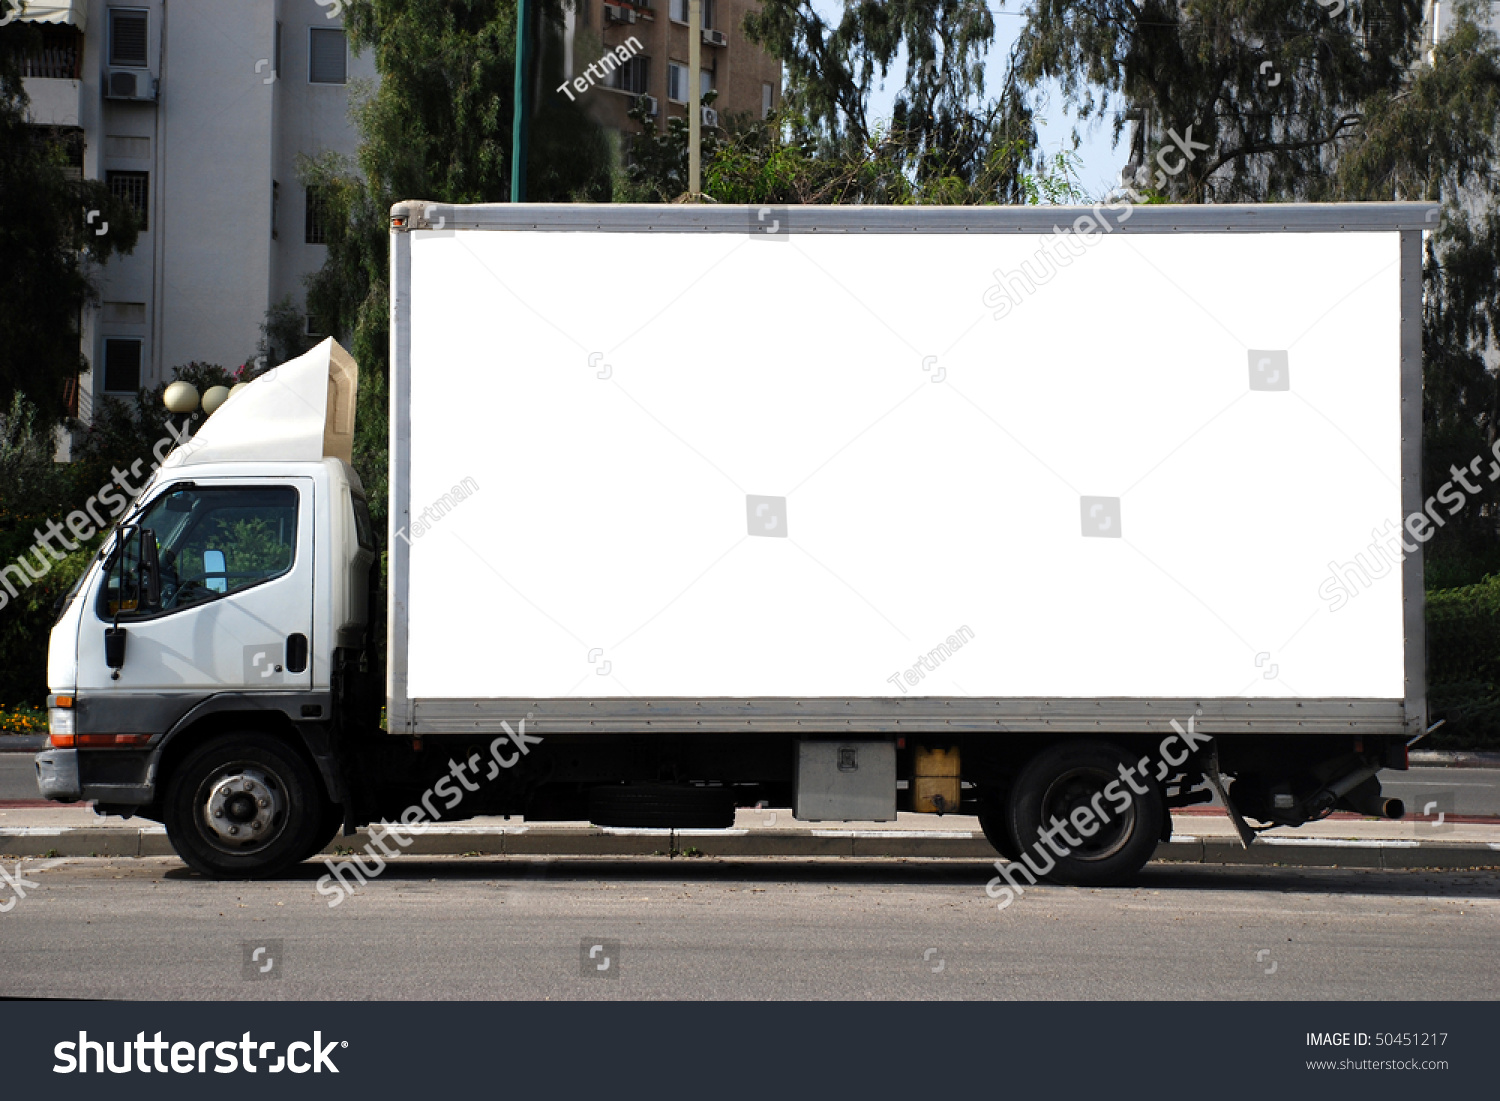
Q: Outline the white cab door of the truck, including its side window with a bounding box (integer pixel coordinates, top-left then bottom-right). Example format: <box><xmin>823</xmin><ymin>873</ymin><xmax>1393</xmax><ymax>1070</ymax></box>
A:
<box><xmin>78</xmin><ymin>477</ymin><xmax>315</xmax><ymax>702</ymax></box>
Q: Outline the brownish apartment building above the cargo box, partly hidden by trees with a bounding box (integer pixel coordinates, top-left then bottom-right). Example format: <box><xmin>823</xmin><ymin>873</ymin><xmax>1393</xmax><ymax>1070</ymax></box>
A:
<box><xmin>564</xmin><ymin>0</ymin><xmax>782</xmax><ymax>143</ymax></box>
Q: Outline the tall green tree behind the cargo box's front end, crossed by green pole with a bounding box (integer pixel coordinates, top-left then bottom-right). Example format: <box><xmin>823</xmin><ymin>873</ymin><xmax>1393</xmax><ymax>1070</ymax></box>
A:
<box><xmin>302</xmin><ymin>0</ymin><xmax>611</xmax><ymax>525</ymax></box>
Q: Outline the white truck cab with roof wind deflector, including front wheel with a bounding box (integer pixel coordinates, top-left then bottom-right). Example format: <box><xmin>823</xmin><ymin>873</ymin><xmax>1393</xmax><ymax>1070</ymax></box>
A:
<box><xmin>36</xmin><ymin>341</ymin><xmax>375</xmax><ymax>875</ymax></box>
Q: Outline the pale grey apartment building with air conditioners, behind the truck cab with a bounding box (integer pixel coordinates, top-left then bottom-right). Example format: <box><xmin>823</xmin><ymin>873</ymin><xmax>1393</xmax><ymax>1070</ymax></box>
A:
<box><xmin>20</xmin><ymin>0</ymin><xmax>375</xmax><ymax>432</ymax></box>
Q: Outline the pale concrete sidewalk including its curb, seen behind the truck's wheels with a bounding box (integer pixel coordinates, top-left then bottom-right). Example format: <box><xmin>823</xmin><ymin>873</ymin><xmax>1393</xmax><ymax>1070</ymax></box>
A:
<box><xmin>0</xmin><ymin>807</ymin><xmax>1500</xmax><ymax>870</ymax></box>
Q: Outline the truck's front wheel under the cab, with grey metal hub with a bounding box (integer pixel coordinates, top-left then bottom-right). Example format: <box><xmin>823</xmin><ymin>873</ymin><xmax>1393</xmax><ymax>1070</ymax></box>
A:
<box><xmin>162</xmin><ymin>732</ymin><xmax>327</xmax><ymax>879</ymax></box>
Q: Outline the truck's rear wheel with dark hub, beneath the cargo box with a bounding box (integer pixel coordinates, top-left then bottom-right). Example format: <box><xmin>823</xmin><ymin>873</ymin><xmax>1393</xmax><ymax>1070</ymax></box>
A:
<box><xmin>1008</xmin><ymin>741</ymin><xmax>1167</xmax><ymax>887</ymax></box>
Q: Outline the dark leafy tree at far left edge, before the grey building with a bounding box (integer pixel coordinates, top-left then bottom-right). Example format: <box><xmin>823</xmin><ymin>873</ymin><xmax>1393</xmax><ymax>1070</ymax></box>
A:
<box><xmin>0</xmin><ymin>23</ymin><xmax>138</xmax><ymax>426</ymax></box>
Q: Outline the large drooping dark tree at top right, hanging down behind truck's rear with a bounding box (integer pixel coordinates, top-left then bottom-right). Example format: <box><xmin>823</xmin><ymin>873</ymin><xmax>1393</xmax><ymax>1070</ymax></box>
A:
<box><xmin>1013</xmin><ymin>0</ymin><xmax>1500</xmax><ymax>584</ymax></box>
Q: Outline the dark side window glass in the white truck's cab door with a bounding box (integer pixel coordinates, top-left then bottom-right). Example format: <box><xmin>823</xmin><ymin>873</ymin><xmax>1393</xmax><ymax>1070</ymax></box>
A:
<box><xmin>99</xmin><ymin>486</ymin><xmax>297</xmax><ymax>620</ymax></box>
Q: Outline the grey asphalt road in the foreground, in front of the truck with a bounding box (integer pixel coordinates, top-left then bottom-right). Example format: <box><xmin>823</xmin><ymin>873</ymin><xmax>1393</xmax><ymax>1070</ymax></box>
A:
<box><xmin>0</xmin><ymin>857</ymin><xmax>1500</xmax><ymax>1001</ymax></box>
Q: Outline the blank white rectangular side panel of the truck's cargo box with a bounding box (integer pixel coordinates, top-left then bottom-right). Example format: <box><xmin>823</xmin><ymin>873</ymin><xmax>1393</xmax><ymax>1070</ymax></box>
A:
<box><xmin>408</xmin><ymin>231</ymin><xmax>1404</xmax><ymax>699</ymax></box>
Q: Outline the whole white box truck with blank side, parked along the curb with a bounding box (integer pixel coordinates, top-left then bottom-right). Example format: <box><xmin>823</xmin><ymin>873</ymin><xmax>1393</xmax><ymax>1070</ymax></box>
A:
<box><xmin>38</xmin><ymin>201</ymin><xmax>1436</xmax><ymax>884</ymax></box>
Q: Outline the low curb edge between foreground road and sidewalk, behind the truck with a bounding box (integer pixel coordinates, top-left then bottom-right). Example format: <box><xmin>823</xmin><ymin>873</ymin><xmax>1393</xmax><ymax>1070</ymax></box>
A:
<box><xmin>0</xmin><ymin>827</ymin><xmax>1500</xmax><ymax>870</ymax></box>
